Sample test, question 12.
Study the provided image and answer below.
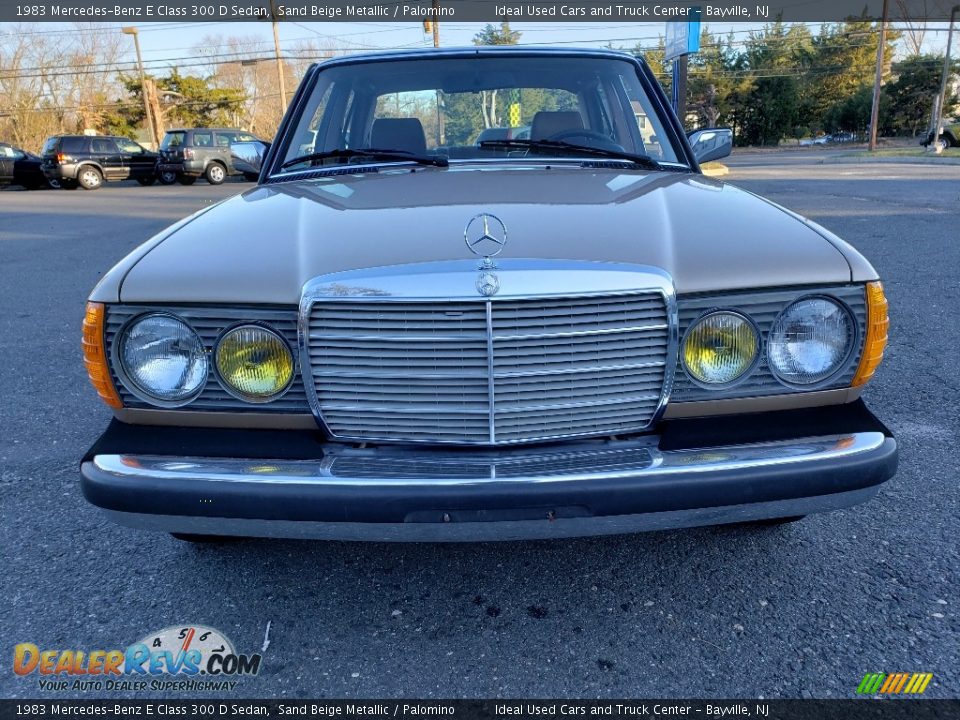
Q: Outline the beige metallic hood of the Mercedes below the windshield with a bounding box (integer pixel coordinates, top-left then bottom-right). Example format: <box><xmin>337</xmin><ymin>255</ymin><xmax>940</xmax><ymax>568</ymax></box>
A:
<box><xmin>116</xmin><ymin>164</ymin><xmax>852</xmax><ymax>304</ymax></box>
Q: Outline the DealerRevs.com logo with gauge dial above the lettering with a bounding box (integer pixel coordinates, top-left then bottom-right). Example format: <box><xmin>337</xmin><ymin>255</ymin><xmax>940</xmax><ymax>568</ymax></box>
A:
<box><xmin>13</xmin><ymin>625</ymin><xmax>261</xmax><ymax>691</ymax></box>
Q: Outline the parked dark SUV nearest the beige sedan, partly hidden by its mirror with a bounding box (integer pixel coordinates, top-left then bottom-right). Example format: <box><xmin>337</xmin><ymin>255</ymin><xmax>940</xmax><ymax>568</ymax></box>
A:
<box><xmin>157</xmin><ymin>128</ymin><xmax>263</xmax><ymax>185</ymax></box>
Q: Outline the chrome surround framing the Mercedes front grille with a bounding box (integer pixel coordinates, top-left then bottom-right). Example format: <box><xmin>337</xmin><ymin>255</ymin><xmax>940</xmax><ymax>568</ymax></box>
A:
<box><xmin>297</xmin><ymin>259</ymin><xmax>679</xmax><ymax>447</ymax></box>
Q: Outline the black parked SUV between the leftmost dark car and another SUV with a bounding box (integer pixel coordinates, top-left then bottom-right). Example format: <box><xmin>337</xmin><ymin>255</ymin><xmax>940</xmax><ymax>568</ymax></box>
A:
<box><xmin>40</xmin><ymin>135</ymin><xmax>159</xmax><ymax>190</ymax></box>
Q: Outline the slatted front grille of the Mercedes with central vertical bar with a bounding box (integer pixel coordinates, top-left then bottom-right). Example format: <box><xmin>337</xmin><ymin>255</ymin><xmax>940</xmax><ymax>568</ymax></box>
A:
<box><xmin>304</xmin><ymin>290</ymin><xmax>672</xmax><ymax>444</ymax></box>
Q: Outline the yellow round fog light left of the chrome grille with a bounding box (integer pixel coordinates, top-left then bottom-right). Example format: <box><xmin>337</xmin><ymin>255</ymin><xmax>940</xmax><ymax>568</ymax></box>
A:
<box><xmin>216</xmin><ymin>325</ymin><xmax>293</xmax><ymax>402</ymax></box>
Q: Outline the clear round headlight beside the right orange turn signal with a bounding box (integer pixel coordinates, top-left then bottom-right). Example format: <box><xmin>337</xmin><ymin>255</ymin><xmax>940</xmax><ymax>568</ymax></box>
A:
<box><xmin>767</xmin><ymin>297</ymin><xmax>856</xmax><ymax>385</ymax></box>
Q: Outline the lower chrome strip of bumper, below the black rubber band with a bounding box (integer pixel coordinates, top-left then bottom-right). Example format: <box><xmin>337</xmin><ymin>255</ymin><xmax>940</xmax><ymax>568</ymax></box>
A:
<box><xmin>104</xmin><ymin>485</ymin><xmax>880</xmax><ymax>542</ymax></box>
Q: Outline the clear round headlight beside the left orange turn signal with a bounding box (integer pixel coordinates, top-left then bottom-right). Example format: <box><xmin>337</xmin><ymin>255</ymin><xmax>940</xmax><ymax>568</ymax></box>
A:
<box><xmin>118</xmin><ymin>313</ymin><xmax>208</xmax><ymax>405</ymax></box>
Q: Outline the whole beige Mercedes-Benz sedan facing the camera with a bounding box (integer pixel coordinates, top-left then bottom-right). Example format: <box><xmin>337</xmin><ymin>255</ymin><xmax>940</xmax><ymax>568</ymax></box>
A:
<box><xmin>82</xmin><ymin>48</ymin><xmax>897</xmax><ymax>540</ymax></box>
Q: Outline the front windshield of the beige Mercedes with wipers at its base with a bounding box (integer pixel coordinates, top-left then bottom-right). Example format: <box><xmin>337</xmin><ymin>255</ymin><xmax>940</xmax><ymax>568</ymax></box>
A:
<box><xmin>280</xmin><ymin>55</ymin><xmax>678</xmax><ymax>171</ymax></box>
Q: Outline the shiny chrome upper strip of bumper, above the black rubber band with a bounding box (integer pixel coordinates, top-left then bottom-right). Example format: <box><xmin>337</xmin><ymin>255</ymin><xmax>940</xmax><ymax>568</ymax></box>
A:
<box><xmin>92</xmin><ymin>432</ymin><xmax>886</xmax><ymax>488</ymax></box>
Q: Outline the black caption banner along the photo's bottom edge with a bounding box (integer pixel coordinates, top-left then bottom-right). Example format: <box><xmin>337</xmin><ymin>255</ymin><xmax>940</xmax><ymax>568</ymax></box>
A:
<box><xmin>0</xmin><ymin>698</ymin><xmax>960</xmax><ymax>720</ymax></box>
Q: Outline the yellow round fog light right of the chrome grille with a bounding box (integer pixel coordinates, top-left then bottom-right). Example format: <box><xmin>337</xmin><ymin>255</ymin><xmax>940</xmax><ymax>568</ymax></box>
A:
<box><xmin>683</xmin><ymin>310</ymin><xmax>760</xmax><ymax>385</ymax></box>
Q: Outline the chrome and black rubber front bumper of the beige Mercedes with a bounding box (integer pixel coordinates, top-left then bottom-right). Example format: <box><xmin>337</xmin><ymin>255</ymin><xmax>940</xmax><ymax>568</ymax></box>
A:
<box><xmin>81</xmin><ymin>431</ymin><xmax>897</xmax><ymax>541</ymax></box>
